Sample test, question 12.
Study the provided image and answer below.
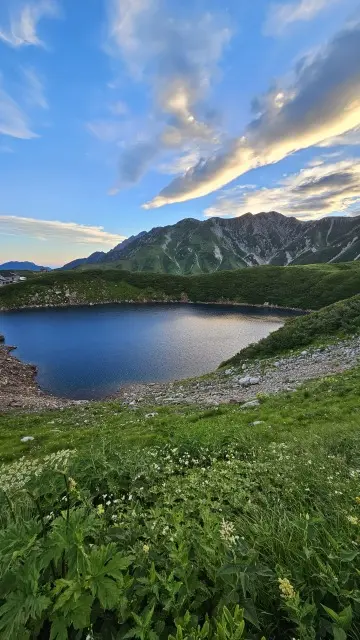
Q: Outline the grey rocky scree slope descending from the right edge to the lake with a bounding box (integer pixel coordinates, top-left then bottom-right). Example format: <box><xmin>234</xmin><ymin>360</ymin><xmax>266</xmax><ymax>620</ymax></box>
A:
<box><xmin>116</xmin><ymin>337</ymin><xmax>360</xmax><ymax>407</ymax></box>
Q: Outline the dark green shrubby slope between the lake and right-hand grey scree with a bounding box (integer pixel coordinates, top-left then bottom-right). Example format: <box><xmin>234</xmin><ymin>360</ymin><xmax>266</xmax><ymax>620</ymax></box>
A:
<box><xmin>222</xmin><ymin>295</ymin><xmax>360</xmax><ymax>366</ymax></box>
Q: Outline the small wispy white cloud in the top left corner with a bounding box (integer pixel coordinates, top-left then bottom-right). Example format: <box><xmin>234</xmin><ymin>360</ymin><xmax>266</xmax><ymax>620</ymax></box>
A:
<box><xmin>0</xmin><ymin>0</ymin><xmax>59</xmax><ymax>47</ymax></box>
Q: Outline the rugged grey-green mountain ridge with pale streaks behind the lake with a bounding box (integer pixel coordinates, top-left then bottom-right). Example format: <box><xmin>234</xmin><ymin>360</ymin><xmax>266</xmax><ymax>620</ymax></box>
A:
<box><xmin>65</xmin><ymin>211</ymin><xmax>360</xmax><ymax>274</ymax></box>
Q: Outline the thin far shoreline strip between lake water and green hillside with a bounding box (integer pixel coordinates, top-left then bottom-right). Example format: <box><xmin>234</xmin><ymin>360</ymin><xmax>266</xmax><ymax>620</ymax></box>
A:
<box><xmin>0</xmin><ymin>299</ymin><xmax>313</xmax><ymax>315</ymax></box>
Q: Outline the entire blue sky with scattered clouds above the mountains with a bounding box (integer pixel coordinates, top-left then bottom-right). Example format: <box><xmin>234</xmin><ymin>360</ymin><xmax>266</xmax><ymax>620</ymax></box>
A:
<box><xmin>0</xmin><ymin>0</ymin><xmax>360</xmax><ymax>266</ymax></box>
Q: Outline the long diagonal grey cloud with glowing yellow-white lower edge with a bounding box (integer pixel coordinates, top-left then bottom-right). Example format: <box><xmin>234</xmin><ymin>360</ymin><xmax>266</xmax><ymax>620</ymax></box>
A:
<box><xmin>145</xmin><ymin>23</ymin><xmax>360</xmax><ymax>208</ymax></box>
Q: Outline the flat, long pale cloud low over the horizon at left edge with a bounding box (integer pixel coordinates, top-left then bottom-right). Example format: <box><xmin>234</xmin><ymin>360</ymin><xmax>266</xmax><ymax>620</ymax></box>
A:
<box><xmin>0</xmin><ymin>215</ymin><xmax>125</xmax><ymax>245</ymax></box>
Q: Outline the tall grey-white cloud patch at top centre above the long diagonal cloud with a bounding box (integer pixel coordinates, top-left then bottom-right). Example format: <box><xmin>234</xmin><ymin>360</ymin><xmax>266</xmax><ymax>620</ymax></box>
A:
<box><xmin>102</xmin><ymin>0</ymin><xmax>231</xmax><ymax>188</ymax></box>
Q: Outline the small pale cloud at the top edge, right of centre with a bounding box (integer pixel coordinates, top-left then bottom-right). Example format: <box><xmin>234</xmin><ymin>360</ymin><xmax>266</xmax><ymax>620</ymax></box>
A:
<box><xmin>264</xmin><ymin>0</ymin><xmax>340</xmax><ymax>35</ymax></box>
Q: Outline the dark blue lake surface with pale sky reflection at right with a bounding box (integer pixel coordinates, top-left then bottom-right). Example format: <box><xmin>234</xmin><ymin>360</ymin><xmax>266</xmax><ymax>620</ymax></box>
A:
<box><xmin>0</xmin><ymin>304</ymin><xmax>289</xmax><ymax>399</ymax></box>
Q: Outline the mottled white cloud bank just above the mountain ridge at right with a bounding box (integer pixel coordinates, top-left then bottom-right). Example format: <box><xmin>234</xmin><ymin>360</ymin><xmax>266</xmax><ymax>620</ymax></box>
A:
<box><xmin>204</xmin><ymin>159</ymin><xmax>360</xmax><ymax>219</ymax></box>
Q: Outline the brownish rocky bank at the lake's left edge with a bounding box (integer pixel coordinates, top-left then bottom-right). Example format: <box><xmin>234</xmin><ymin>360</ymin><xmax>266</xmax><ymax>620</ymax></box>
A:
<box><xmin>0</xmin><ymin>344</ymin><xmax>83</xmax><ymax>413</ymax></box>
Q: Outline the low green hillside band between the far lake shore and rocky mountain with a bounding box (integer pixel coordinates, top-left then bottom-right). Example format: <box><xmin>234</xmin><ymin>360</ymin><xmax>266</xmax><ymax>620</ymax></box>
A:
<box><xmin>0</xmin><ymin>262</ymin><xmax>360</xmax><ymax>309</ymax></box>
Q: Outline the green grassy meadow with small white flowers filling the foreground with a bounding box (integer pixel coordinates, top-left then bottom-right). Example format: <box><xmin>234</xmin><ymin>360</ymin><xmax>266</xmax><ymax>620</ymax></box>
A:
<box><xmin>0</xmin><ymin>368</ymin><xmax>360</xmax><ymax>640</ymax></box>
